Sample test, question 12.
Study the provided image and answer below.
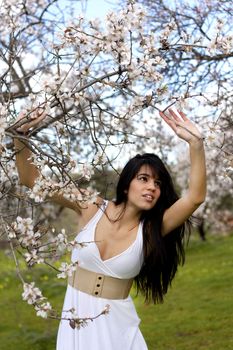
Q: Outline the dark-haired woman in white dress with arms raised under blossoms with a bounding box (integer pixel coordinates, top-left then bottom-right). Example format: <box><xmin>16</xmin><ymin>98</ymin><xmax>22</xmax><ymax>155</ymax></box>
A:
<box><xmin>15</xmin><ymin>109</ymin><xmax>206</xmax><ymax>350</ymax></box>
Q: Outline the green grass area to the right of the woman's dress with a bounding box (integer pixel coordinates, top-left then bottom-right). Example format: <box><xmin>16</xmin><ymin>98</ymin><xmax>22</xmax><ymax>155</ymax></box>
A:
<box><xmin>136</xmin><ymin>236</ymin><xmax>233</xmax><ymax>350</ymax></box>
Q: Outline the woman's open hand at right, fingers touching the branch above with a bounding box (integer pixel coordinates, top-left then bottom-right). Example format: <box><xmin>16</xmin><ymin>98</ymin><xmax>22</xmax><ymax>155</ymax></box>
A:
<box><xmin>159</xmin><ymin>108</ymin><xmax>203</xmax><ymax>143</ymax></box>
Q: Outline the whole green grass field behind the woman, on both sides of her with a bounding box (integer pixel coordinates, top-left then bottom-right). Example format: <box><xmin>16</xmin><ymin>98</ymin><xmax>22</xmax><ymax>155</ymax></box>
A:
<box><xmin>0</xmin><ymin>235</ymin><xmax>233</xmax><ymax>350</ymax></box>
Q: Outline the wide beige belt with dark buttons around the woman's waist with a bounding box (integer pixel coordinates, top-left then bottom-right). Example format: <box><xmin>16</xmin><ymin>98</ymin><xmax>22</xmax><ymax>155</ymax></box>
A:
<box><xmin>68</xmin><ymin>266</ymin><xmax>133</xmax><ymax>299</ymax></box>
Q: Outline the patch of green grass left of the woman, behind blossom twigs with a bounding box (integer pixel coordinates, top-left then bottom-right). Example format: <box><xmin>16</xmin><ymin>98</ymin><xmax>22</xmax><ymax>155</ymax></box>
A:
<box><xmin>0</xmin><ymin>253</ymin><xmax>62</xmax><ymax>350</ymax></box>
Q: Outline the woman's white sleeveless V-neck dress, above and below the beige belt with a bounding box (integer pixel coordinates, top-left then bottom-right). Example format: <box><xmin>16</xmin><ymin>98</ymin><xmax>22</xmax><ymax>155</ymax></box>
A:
<box><xmin>57</xmin><ymin>201</ymin><xmax>147</xmax><ymax>350</ymax></box>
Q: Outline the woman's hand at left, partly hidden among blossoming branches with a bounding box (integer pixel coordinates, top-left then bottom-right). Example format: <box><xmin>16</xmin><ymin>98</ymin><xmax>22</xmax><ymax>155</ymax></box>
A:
<box><xmin>15</xmin><ymin>108</ymin><xmax>47</xmax><ymax>134</ymax></box>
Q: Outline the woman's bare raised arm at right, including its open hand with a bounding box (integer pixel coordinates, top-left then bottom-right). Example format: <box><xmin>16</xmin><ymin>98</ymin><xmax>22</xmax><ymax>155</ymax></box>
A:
<box><xmin>160</xmin><ymin>109</ymin><xmax>206</xmax><ymax>235</ymax></box>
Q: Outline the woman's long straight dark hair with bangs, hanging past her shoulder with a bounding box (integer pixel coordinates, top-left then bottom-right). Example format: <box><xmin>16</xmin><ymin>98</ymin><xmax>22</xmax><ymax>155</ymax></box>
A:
<box><xmin>115</xmin><ymin>153</ymin><xmax>190</xmax><ymax>303</ymax></box>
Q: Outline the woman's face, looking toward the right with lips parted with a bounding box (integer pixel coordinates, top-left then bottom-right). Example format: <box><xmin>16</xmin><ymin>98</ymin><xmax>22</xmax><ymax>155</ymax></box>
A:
<box><xmin>127</xmin><ymin>165</ymin><xmax>161</xmax><ymax>210</ymax></box>
